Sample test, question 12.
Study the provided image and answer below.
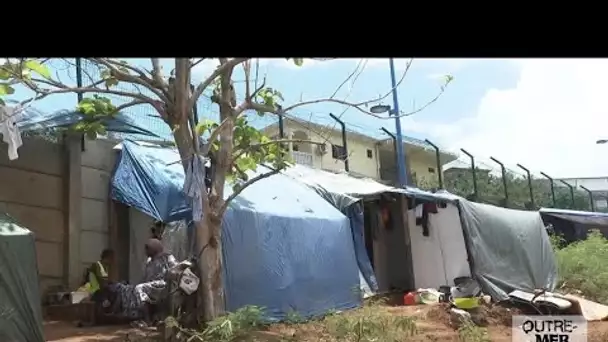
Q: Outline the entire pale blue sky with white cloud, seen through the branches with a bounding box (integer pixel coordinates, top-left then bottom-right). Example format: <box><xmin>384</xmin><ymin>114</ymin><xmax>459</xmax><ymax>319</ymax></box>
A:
<box><xmin>3</xmin><ymin>59</ymin><xmax>608</xmax><ymax>177</ymax></box>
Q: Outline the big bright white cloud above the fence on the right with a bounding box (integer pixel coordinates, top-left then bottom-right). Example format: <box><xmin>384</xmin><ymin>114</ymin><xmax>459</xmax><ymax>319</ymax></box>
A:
<box><xmin>427</xmin><ymin>59</ymin><xmax>608</xmax><ymax>177</ymax></box>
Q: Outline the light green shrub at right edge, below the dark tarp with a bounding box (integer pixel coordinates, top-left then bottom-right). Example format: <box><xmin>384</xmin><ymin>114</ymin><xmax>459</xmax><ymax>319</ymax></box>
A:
<box><xmin>552</xmin><ymin>231</ymin><xmax>608</xmax><ymax>304</ymax></box>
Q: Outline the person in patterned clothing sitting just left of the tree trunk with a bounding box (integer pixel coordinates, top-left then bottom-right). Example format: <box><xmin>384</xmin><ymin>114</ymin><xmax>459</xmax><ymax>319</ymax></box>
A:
<box><xmin>116</xmin><ymin>239</ymin><xmax>177</xmax><ymax>325</ymax></box>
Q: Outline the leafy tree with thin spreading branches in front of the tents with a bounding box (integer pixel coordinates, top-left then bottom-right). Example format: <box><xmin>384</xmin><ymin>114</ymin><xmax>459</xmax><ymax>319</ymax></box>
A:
<box><xmin>0</xmin><ymin>58</ymin><xmax>452</xmax><ymax>320</ymax></box>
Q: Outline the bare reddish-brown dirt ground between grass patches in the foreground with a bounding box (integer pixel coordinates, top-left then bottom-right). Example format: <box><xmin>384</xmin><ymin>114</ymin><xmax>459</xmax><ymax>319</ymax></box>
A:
<box><xmin>44</xmin><ymin>305</ymin><xmax>608</xmax><ymax>342</ymax></box>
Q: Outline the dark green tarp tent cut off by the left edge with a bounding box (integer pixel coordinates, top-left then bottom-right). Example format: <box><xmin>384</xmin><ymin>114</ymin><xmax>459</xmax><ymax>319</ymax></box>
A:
<box><xmin>0</xmin><ymin>213</ymin><xmax>45</xmax><ymax>342</ymax></box>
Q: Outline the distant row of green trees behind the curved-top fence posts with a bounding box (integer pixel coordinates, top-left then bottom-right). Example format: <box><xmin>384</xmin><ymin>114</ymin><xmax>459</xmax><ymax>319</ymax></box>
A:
<box><xmin>418</xmin><ymin>168</ymin><xmax>590</xmax><ymax>210</ymax></box>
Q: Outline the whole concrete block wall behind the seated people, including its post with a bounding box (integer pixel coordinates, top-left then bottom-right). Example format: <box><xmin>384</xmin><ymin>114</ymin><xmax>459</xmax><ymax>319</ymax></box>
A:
<box><xmin>0</xmin><ymin>138</ymin><xmax>116</xmax><ymax>292</ymax></box>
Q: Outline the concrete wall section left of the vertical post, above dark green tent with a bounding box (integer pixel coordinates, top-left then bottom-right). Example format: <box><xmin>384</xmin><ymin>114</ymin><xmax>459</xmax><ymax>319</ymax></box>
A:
<box><xmin>0</xmin><ymin>138</ymin><xmax>66</xmax><ymax>288</ymax></box>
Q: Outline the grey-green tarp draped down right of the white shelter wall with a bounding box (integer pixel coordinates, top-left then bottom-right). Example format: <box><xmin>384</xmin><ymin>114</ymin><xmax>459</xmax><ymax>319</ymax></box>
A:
<box><xmin>459</xmin><ymin>199</ymin><xmax>557</xmax><ymax>300</ymax></box>
